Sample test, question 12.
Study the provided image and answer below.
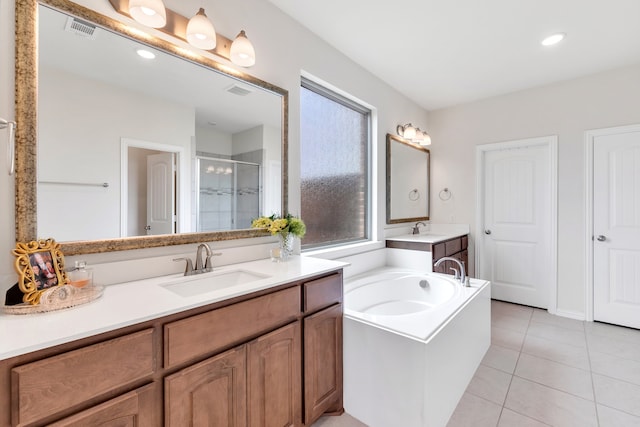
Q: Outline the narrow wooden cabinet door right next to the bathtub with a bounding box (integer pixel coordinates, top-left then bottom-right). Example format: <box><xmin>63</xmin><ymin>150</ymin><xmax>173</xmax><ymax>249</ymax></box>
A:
<box><xmin>304</xmin><ymin>304</ymin><xmax>342</xmax><ymax>425</ymax></box>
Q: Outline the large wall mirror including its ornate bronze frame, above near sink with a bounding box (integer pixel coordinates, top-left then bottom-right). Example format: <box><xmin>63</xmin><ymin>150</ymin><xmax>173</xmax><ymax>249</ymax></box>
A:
<box><xmin>16</xmin><ymin>0</ymin><xmax>288</xmax><ymax>255</ymax></box>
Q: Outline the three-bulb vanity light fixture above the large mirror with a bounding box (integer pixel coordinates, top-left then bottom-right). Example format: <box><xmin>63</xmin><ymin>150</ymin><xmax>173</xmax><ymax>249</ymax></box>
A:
<box><xmin>109</xmin><ymin>0</ymin><xmax>256</xmax><ymax>67</ymax></box>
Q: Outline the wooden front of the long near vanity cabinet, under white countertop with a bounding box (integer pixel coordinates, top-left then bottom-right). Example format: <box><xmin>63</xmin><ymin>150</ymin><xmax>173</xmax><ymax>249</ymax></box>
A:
<box><xmin>0</xmin><ymin>270</ymin><xmax>343</xmax><ymax>427</ymax></box>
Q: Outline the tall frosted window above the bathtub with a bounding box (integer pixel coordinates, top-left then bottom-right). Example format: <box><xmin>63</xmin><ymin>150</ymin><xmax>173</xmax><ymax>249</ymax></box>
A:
<box><xmin>300</xmin><ymin>79</ymin><xmax>371</xmax><ymax>249</ymax></box>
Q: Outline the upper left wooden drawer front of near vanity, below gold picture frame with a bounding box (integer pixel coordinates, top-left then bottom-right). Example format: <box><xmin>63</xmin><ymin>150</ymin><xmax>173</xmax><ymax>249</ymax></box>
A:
<box><xmin>11</xmin><ymin>329</ymin><xmax>155</xmax><ymax>425</ymax></box>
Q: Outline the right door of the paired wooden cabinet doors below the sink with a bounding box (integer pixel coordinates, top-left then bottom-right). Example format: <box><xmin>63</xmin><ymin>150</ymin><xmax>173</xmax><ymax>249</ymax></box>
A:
<box><xmin>247</xmin><ymin>321</ymin><xmax>302</xmax><ymax>427</ymax></box>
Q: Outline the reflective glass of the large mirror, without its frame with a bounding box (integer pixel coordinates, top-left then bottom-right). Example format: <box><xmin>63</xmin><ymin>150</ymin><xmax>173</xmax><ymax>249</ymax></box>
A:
<box><xmin>38</xmin><ymin>6</ymin><xmax>282</xmax><ymax>241</ymax></box>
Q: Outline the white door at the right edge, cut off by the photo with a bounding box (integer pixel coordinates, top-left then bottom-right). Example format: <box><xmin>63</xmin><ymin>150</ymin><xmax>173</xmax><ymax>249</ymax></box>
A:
<box><xmin>593</xmin><ymin>126</ymin><xmax>640</xmax><ymax>328</ymax></box>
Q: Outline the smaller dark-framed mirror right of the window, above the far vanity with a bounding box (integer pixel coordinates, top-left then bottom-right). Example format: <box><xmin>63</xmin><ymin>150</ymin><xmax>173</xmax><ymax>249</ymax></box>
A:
<box><xmin>387</xmin><ymin>134</ymin><xmax>430</xmax><ymax>224</ymax></box>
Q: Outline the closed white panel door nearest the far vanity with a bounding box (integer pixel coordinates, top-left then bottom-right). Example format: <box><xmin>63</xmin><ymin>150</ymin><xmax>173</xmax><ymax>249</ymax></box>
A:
<box><xmin>478</xmin><ymin>137</ymin><xmax>556</xmax><ymax>308</ymax></box>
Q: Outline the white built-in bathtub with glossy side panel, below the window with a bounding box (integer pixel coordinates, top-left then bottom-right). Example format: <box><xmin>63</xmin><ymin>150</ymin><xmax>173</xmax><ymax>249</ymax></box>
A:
<box><xmin>344</xmin><ymin>267</ymin><xmax>491</xmax><ymax>427</ymax></box>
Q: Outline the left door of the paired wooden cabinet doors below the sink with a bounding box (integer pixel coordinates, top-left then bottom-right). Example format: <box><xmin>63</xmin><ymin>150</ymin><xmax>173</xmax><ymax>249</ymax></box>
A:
<box><xmin>164</xmin><ymin>346</ymin><xmax>247</xmax><ymax>427</ymax></box>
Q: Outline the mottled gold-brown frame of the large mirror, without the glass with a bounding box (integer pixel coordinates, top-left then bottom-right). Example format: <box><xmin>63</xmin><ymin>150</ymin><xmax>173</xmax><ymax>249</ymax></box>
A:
<box><xmin>15</xmin><ymin>0</ymin><xmax>289</xmax><ymax>255</ymax></box>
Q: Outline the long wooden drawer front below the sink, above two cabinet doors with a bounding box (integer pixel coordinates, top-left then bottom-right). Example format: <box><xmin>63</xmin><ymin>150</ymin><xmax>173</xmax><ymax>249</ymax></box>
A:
<box><xmin>164</xmin><ymin>286</ymin><xmax>300</xmax><ymax>368</ymax></box>
